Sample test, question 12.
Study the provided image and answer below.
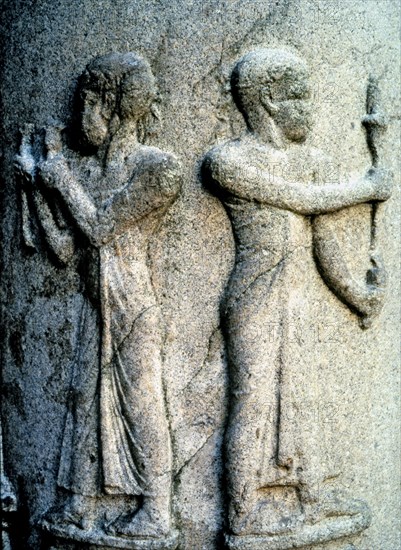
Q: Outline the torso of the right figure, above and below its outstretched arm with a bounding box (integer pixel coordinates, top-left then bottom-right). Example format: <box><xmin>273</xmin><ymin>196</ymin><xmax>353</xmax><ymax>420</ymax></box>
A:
<box><xmin>206</xmin><ymin>136</ymin><xmax>322</xmax><ymax>308</ymax></box>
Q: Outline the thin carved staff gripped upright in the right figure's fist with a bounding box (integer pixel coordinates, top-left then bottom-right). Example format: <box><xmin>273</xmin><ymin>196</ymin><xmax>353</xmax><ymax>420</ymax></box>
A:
<box><xmin>362</xmin><ymin>74</ymin><xmax>387</xmax><ymax>251</ymax></box>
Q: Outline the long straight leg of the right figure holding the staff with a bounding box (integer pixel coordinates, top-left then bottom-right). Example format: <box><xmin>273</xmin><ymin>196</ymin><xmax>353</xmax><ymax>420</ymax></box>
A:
<box><xmin>226</xmin><ymin>279</ymin><xmax>281</xmax><ymax>534</ymax></box>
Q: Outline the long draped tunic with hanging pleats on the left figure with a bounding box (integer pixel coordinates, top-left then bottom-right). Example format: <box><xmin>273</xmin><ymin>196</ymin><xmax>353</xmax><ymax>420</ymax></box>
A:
<box><xmin>58</xmin><ymin>148</ymin><xmax>179</xmax><ymax>496</ymax></box>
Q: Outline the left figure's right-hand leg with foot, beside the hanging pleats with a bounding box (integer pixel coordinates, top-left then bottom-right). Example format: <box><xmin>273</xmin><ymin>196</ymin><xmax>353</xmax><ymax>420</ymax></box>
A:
<box><xmin>105</xmin><ymin>307</ymin><xmax>171</xmax><ymax>537</ymax></box>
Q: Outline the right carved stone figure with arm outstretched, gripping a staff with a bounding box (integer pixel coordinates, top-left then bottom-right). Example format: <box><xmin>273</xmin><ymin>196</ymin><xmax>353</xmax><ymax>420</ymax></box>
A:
<box><xmin>204</xmin><ymin>49</ymin><xmax>391</xmax><ymax>549</ymax></box>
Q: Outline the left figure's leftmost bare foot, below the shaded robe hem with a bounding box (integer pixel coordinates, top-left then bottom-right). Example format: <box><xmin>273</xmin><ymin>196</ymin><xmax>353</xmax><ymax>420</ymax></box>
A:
<box><xmin>43</xmin><ymin>495</ymin><xmax>91</xmax><ymax>530</ymax></box>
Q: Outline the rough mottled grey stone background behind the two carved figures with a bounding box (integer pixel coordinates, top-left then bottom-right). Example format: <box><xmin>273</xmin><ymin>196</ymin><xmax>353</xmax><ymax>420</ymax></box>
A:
<box><xmin>1</xmin><ymin>0</ymin><xmax>400</xmax><ymax>550</ymax></box>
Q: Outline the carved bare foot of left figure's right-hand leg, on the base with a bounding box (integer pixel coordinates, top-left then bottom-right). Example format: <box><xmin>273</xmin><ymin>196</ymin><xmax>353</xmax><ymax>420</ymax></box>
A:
<box><xmin>106</xmin><ymin>501</ymin><xmax>170</xmax><ymax>538</ymax></box>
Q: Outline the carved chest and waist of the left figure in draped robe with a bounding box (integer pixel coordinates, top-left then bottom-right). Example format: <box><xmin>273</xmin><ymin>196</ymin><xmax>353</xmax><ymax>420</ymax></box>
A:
<box><xmin>73</xmin><ymin>146</ymin><xmax>178</xmax><ymax>314</ymax></box>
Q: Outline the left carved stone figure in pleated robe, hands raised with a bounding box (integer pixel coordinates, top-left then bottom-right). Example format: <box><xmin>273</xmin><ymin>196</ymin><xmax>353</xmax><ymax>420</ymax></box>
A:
<box><xmin>16</xmin><ymin>53</ymin><xmax>181</xmax><ymax>548</ymax></box>
